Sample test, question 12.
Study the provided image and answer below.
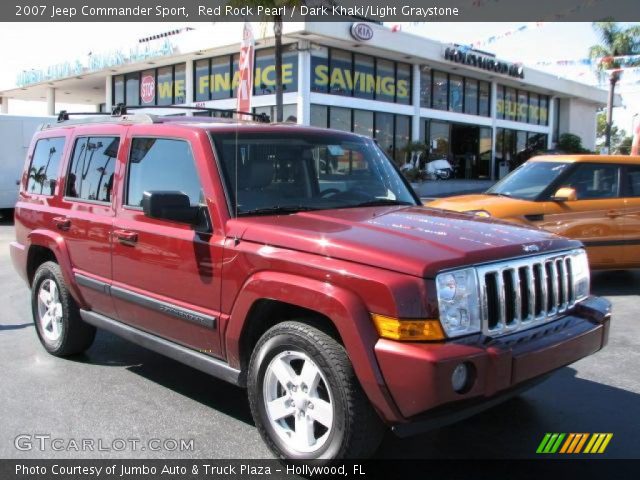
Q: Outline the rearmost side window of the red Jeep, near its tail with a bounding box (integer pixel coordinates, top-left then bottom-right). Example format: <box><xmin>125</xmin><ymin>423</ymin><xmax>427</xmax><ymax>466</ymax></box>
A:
<box><xmin>27</xmin><ymin>138</ymin><xmax>64</xmax><ymax>195</ymax></box>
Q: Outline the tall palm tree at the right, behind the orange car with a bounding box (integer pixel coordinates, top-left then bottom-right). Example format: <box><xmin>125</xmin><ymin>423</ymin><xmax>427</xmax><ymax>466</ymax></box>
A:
<box><xmin>589</xmin><ymin>21</ymin><xmax>640</xmax><ymax>150</ymax></box>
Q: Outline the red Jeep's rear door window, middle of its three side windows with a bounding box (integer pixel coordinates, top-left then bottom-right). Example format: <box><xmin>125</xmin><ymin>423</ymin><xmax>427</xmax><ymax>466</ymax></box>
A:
<box><xmin>65</xmin><ymin>137</ymin><xmax>120</xmax><ymax>202</ymax></box>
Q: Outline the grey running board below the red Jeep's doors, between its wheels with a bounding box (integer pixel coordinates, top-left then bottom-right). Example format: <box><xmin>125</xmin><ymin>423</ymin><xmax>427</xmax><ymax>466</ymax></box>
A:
<box><xmin>80</xmin><ymin>310</ymin><xmax>243</xmax><ymax>386</ymax></box>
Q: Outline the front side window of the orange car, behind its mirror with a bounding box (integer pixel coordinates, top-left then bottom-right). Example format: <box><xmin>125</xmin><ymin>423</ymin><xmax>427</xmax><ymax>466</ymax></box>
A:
<box><xmin>562</xmin><ymin>163</ymin><xmax>620</xmax><ymax>200</ymax></box>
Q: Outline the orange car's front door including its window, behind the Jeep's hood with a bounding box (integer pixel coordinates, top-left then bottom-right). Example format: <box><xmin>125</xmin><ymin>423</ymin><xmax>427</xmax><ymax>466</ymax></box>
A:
<box><xmin>539</xmin><ymin>163</ymin><xmax>624</xmax><ymax>268</ymax></box>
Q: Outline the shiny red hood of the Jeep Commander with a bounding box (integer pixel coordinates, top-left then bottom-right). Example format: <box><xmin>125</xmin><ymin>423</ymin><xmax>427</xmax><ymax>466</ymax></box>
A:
<box><xmin>227</xmin><ymin>206</ymin><xmax>580</xmax><ymax>278</ymax></box>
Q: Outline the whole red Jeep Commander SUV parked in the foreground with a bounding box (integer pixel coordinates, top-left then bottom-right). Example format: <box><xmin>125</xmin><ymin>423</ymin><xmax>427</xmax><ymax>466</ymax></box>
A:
<box><xmin>11</xmin><ymin>110</ymin><xmax>610</xmax><ymax>460</ymax></box>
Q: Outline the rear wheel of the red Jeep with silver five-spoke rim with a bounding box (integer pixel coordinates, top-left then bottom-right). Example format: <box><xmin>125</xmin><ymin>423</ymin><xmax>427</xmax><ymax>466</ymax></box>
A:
<box><xmin>31</xmin><ymin>262</ymin><xmax>96</xmax><ymax>357</ymax></box>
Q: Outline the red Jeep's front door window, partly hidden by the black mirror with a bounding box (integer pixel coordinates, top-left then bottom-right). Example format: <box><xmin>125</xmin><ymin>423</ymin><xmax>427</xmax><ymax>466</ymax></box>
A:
<box><xmin>126</xmin><ymin>138</ymin><xmax>201</xmax><ymax>207</ymax></box>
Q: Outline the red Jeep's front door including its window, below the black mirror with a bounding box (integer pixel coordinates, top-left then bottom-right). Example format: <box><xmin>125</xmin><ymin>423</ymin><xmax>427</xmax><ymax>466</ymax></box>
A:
<box><xmin>111</xmin><ymin>136</ymin><xmax>223</xmax><ymax>356</ymax></box>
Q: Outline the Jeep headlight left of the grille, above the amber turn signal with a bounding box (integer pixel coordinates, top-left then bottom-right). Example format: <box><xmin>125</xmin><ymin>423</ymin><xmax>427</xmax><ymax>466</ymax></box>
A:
<box><xmin>436</xmin><ymin>268</ymin><xmax>480</xmax><ymax>337</ymax></box>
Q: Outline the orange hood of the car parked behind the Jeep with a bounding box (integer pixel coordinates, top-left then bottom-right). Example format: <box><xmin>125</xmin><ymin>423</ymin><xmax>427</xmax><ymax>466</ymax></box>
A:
<box><xmin>425</xmin><ymin>195</ymin><xmax>544</xmax><ymax>219</ymax></box>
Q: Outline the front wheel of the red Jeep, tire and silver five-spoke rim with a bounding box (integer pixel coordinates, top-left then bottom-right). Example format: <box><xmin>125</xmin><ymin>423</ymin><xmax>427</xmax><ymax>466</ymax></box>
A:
<box><xmin>247</xmin><ymin>321</ymin><xmax>385</xmax><ymax>462</ymax></box>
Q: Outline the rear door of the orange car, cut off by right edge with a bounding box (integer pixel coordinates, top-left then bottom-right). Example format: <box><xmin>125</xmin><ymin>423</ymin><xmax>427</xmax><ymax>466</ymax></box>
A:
<box><xmin>622</xmin><ymin>165</ymin><xmax>640</xmax><ymax>267</ymax></box>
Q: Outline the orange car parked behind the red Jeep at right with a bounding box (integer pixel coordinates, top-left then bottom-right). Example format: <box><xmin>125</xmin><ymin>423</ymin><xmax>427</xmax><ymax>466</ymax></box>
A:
<box><xmin>427</xmin><ymin>155</ymin><xmax>640</xmax><ymax>269</ymax></box>
